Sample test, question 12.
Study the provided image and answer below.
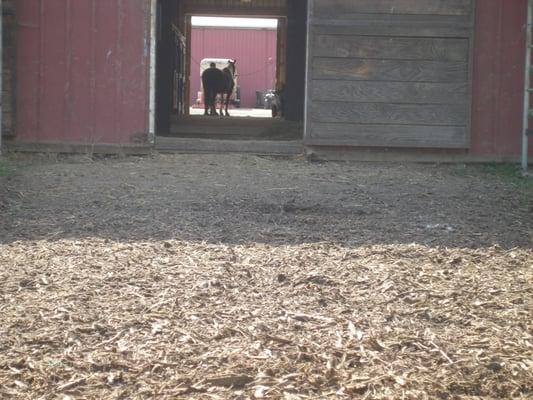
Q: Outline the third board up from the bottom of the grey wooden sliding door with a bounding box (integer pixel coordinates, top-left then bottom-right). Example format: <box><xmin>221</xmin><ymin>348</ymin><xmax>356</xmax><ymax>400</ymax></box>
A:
<box><xmin>311</xmin><ymin>80</ymin><xmax>468</xmax><ymax>106</ymax></box>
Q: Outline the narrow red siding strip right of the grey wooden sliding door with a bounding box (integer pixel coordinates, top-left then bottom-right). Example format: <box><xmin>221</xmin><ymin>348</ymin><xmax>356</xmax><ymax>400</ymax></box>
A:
<box><xmin>471</xmin><ymin>0</ymin><xmax>533</xmax><ymax>156</ymax></box>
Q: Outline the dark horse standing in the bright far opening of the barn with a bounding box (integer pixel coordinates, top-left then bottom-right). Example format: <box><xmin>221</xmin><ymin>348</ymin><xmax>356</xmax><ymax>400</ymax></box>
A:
<box><xmin>202</xmin><ymin>60</ymin><xmax>237</xmax><ymax>117</ymax></box>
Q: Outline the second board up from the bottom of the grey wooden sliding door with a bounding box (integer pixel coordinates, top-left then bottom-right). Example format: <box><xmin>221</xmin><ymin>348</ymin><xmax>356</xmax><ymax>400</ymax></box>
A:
<box><xmin>310</xmin><ymin>101</ymin><xmax>468</xmax><ymax>126</ymax></box>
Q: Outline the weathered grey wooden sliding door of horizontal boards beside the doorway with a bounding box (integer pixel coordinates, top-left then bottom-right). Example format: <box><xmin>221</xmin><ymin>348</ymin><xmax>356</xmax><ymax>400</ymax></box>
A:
<box><xmin>305</xmin><ymin>0</ymin><xmax>474</xmax><ymax>148</ymax></box>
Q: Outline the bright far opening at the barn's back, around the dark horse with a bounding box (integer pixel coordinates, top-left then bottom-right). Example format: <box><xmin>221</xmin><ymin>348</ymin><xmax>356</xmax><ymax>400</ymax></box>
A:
<box><xmin>189</xmin><ymin>16</ymin><xmax>278</xmax><ymax>118</ymax></box>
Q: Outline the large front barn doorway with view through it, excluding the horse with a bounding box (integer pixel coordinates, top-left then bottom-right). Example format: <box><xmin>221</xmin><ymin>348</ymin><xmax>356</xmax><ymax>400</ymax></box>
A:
<box><xmin>156</xmin><ymin>0</ymin><xmax>307</xmax><ymax>144</ymax></box>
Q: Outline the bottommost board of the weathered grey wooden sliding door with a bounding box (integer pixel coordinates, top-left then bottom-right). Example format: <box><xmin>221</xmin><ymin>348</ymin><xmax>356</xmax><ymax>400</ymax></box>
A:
<box><xmin>306</xmin><ymin>123</ymin><xmax>468</xmax><ymax>148</ymax></box>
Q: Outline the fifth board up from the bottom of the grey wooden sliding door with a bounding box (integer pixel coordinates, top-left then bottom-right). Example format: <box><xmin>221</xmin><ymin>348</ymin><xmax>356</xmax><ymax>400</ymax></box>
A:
<box><xmin>314</xmin><ymin>35</ymin><xmax>469</xmax><ymax>61</ymax></box>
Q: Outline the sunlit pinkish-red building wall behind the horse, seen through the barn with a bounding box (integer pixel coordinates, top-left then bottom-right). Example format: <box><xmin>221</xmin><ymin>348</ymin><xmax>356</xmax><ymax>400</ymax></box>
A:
<box><xmin>191</xmin><ymin>27</ymin><xmax>277</xmax><ymax>107</ymax></box>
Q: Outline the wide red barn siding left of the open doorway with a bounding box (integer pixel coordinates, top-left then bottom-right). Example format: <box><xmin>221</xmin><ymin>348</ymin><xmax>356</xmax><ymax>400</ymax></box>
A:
<box><xmin>17</xmin><ymin>0</ymin><xmax>149</xmax><ymax>144</ymax></box>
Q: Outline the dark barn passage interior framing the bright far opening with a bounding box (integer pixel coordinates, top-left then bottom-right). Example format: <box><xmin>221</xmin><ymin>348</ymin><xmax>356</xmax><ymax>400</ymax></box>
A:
<box><xmin>156</xmin><ymin>0</ymin><xmax>307</xmax><ymax>150</ymax></box>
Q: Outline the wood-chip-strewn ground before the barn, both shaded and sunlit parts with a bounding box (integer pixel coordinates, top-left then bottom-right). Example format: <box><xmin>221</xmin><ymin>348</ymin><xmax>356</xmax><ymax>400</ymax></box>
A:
<box><xmin>0</xmin><ymin>156</ymin><xmax>533</xmax><ymax>399</ymax></box>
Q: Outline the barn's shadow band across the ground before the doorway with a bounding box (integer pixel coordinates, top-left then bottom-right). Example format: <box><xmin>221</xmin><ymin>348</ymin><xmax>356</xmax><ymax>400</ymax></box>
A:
<box><xmin>0</xmin><ymin>155</ymin><xmax>533</xmax><ymax>248</ymax></box>
